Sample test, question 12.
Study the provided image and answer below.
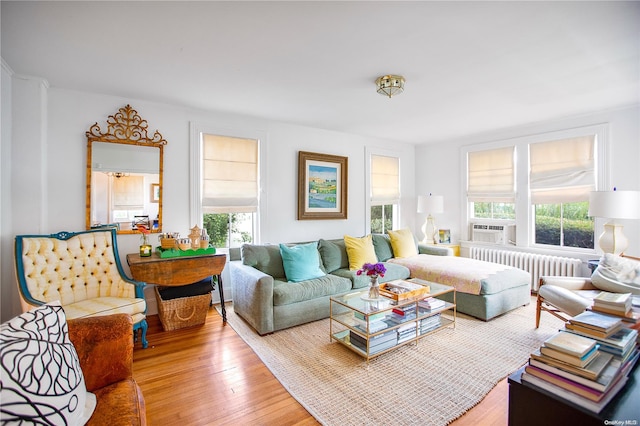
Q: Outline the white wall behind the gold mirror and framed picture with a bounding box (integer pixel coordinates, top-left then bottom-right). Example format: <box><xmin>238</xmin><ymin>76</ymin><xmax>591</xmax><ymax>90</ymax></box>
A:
<box><xmin>2</xmin><ymin>77</ymin><xmax>415</xmax><ymax>320</ymax></box>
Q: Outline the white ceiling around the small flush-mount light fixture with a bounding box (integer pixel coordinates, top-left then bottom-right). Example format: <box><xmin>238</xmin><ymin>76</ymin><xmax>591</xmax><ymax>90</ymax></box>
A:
<box><xmin>1</xmin><ymin>0</ymin><xmax>640</xmax><ymax>144</ymax></box>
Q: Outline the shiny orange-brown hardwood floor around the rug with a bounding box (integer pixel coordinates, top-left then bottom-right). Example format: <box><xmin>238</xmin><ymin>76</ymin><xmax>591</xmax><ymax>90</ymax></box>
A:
<box><xmin>133</xmin><ymin>308</ymin><xmax>508</xmax><ymax>426</ymax></box>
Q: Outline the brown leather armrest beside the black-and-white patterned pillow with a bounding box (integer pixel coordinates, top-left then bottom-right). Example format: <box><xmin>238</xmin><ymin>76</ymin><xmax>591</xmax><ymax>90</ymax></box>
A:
<box><xmin>67</xmin><ymin>314</ymin><xmax>133</xmax><ymax>392</ymax></box>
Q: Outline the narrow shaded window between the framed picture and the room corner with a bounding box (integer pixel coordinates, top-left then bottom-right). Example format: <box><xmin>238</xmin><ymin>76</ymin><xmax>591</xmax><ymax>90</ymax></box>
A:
<box><xmin>370</xmin><ymin>154</ymin><xmax>400</xmax><ymax>234</ymax></box>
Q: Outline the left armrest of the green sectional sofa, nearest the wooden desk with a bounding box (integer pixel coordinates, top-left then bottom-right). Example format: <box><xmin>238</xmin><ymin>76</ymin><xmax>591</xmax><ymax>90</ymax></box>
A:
<box><xmin>229</xmin><ymin>260</ymin><xmax>274</xmax><ymax>335</ymax></box>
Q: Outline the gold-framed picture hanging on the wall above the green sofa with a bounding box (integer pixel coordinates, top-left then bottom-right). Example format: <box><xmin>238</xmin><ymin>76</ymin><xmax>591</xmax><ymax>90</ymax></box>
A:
<box><xmin>298</xmin><ymin>151</ymin><xmax>348</xmax><ymax>220</ymax></box>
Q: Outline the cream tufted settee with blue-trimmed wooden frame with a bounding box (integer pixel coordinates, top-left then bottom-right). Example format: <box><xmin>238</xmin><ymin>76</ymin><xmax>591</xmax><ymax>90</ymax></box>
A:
<box><xmin>15</xmin><ymin>229</ymin><xmax>148</xmax><ymax>348</ymax></box>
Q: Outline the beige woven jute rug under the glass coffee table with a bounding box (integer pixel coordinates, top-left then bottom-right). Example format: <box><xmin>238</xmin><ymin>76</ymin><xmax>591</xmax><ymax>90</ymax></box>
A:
<box><xmin>220</xmin><ymin>299</ymin><xmax>562</xmax><ymax>425</ymax></box>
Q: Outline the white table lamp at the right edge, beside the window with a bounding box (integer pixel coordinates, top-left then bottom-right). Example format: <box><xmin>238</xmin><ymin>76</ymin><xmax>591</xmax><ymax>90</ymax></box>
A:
<box><xmin>588</xmin><ymin>188</ymin><xmax>640</xmax><ymax>255</ymax></box>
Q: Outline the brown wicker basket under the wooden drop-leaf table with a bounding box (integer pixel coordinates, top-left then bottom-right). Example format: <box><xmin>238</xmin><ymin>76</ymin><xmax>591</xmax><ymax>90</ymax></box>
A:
<box><xmin>155</xmin><ymin>286</ymin><xmax>211</xmax><ymax>331</ymax></box>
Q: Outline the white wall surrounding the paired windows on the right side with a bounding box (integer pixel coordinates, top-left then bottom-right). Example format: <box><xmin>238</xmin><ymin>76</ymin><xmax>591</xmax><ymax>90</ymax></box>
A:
<box><xmin>416</xmin><ymin>105</ymin><xmax>640</xmax><ymax>258</ymax></box>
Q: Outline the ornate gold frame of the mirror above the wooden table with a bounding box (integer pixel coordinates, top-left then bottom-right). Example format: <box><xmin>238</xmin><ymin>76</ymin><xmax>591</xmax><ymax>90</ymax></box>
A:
<box><xmin>85</xmin><ymin>104</ymin><xmax>167</xmax><ymax>234</ymax></box>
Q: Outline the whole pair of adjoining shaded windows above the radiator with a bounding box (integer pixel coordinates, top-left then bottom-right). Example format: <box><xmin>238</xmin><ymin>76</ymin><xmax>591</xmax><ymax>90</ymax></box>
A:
<box><xmin>462</xmin><ymin>125</ymin><xmax>609</xmax><ymax>251</ymax></box>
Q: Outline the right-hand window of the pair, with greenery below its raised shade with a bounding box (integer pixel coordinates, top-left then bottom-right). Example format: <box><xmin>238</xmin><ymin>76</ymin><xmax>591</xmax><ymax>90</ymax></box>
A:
<box><xmin>529</xmin><ymin>135</ymin><xmax>596</xmax><ymax>249</ymax></box>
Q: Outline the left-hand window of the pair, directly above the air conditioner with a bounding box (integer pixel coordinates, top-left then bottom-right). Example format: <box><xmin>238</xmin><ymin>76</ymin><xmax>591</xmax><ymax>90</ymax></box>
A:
<box><xmin>467</xmin><ymin>146</ymin><xmax>515</xmax><ymax>219</ymax></box>
